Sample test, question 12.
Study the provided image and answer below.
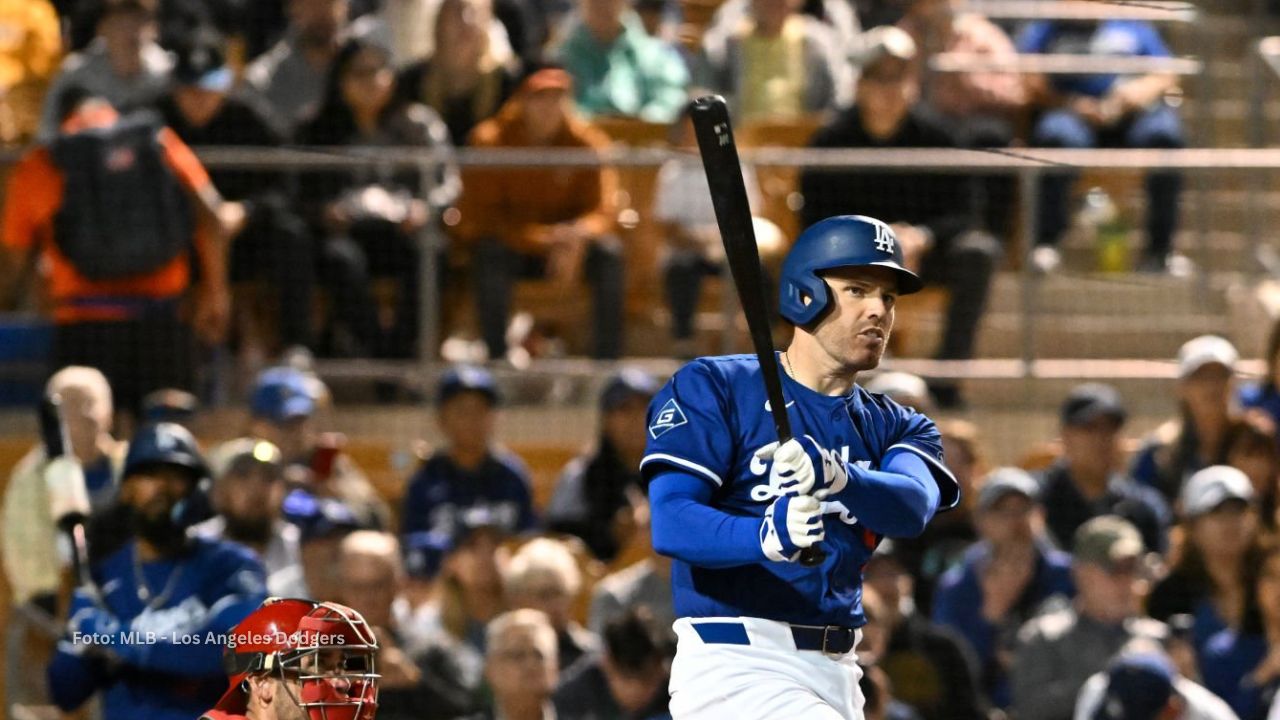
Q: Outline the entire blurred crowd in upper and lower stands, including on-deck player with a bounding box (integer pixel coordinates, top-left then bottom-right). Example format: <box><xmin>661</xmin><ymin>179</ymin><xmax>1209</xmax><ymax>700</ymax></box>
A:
<box><xmin>0</xmin><ymin>0</ymin><xmax>1280</xmax><ymax>720</ymax></box>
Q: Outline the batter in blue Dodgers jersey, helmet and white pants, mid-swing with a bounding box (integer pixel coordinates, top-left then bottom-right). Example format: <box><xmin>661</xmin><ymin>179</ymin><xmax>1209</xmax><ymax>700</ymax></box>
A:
<box><xmin>640</xmin><ymin>215</ymin><xmax>960</xmax><ymax>720</ymax></box>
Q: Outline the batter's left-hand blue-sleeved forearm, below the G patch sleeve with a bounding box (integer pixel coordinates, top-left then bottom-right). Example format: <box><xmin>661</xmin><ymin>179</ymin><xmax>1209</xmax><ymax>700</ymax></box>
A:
<box><xmin>649</xmin><ymin>473</ymin><xmax>767</xmax><ymax>568</ymax></box>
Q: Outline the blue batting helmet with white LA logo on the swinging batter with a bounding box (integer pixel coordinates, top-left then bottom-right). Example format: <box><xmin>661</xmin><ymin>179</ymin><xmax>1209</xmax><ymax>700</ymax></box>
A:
<box><xmin>778</xmin><ymin>215</ymin><xmax>924</xmax><ymax>325</ymax></box>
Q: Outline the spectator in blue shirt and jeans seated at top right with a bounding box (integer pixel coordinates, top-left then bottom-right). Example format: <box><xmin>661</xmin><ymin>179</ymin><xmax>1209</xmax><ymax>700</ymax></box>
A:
<box><xmin>1018</xmin><ymin>20</ymin><xmax>1184</xmax><ymax>272</ymax></box>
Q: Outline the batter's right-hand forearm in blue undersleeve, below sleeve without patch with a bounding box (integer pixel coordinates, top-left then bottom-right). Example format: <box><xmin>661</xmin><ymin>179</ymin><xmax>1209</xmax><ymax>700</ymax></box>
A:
<box><xmin>827</xmin><ymin>451</ymin><xmax>941</xmax><ymax>538</ymax></box>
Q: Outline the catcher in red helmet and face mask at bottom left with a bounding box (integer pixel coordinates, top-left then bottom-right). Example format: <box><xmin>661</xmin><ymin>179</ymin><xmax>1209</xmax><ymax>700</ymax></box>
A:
<box><xmin>201</xmin><ymin>597</ymin><xmax>378</xmax><ymax>720</ymax></box>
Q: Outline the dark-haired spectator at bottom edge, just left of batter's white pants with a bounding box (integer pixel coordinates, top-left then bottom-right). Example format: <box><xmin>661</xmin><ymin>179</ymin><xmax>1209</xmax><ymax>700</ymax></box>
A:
<box><xmin>554</xmin><ymin>609</ymin><xmax>675</xmax><ymax>720</ymax></box>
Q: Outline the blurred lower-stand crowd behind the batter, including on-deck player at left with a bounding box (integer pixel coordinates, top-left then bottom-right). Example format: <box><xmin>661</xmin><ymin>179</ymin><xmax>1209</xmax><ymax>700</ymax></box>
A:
<box><xmin>3</xmin><ymin>315</ymin><xmax>1280</xmax><ymax>720</ymax></box>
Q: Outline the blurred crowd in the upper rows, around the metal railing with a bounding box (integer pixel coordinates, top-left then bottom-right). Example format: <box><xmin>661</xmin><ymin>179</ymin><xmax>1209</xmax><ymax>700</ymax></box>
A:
<box><xmin>0</xmin><ymin>0</ymin><xmax>1184</xmax><ymax>415</ymax></box>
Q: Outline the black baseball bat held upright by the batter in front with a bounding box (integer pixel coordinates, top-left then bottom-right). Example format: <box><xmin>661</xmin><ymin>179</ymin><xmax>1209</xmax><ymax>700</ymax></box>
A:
<box><xmin>689</xmin><ymin>95</ymin><xmax>827</xmax><ymax>566</ymax></box>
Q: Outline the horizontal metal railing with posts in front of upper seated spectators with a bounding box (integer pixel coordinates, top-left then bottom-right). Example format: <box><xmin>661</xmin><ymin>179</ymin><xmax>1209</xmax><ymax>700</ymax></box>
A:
<box><xmin>0</xmin><ymin>146</ymin><xmax>1264</xmax><ymax>377</ymax></box>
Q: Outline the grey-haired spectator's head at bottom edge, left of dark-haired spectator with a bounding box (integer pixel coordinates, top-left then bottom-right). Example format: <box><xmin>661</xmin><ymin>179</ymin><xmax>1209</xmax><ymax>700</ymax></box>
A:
<box><xmin>476</xmin><ymin>609</ymin><xmax>559</xmax><ymax>720</ymax></box>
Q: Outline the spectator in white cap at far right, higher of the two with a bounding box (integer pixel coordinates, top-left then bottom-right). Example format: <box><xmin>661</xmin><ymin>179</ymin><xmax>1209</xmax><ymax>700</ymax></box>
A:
<box><xmin>1132</xmin><ymin>336</ymin><xmax>1240</xmax><ymax>502</ymax></box>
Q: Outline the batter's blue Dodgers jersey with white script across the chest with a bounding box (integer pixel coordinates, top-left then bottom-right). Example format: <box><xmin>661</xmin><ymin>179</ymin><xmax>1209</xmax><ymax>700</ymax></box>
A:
<box><xmin>640</xmin><ymin>355</ymin><xmax>956</xmax><ymax>626</ymax></box>
